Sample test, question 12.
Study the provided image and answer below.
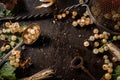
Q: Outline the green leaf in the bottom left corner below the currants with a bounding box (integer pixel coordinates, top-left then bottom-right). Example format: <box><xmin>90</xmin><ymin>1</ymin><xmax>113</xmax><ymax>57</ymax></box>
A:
<box><xmin>0</xmin><ymin>62</ymin><xmax>16</xmax><ymax>80</ymax></box>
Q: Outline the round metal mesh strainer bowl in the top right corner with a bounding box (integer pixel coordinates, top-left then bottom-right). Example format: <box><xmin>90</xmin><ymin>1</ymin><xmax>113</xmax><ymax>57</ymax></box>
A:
<box><xmin>79</xmin><ymin>0</ymin><xmax>120</xmax><ymax>34</ymax></box>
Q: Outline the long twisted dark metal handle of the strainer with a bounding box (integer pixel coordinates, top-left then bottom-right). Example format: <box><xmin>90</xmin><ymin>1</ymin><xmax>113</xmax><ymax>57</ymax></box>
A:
<box><xmin>0</xmin><ymin>4</ymin><xmax>82</xmax><ymax>21</ymax></box>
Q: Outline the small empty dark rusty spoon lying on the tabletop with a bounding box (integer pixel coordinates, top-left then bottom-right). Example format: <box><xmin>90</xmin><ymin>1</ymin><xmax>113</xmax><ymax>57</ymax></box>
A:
<box><xmin>71</xmin><ymin>56</ymin><xmax>96</xmax><ymax>80</ymax></box>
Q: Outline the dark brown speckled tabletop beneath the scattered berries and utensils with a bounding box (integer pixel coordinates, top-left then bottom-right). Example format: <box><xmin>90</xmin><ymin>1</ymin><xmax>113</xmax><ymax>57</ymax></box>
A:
<box><xmin>0</xmin><ymin>0</ymin><xmax>119</xmax><ymax>80</ymax></box>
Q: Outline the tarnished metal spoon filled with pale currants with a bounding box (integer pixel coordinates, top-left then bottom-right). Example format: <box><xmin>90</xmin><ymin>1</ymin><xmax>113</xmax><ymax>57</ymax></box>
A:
<box><xmin>0</xmin><ymin>24</ymin><xmax>41</xmax><ymax>66</ymax></box>
